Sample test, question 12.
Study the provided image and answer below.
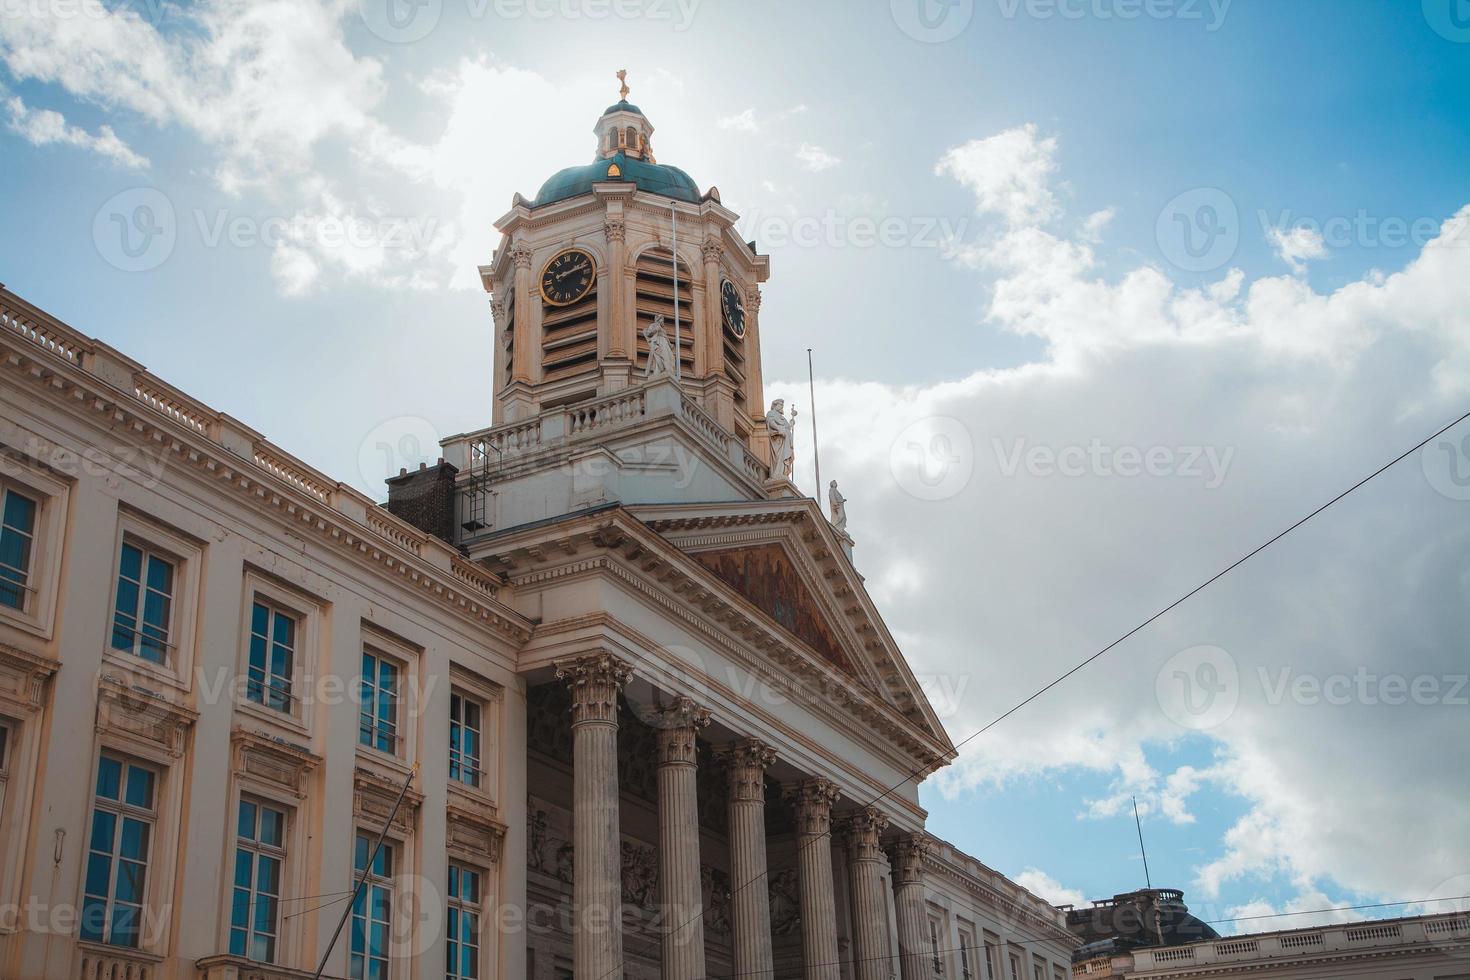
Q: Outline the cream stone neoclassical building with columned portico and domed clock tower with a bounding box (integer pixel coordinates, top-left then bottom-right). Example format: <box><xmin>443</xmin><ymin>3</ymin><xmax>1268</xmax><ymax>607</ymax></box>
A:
<box><xmin>0</xmin><ymin>90</ymin><xmax>1078</xmax><ymax>980</ymax></box>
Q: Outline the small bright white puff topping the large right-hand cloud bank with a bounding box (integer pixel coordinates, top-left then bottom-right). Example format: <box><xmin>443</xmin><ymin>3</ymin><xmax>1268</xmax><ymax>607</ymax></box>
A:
<box><xmin>935</xmin><ymin>123</ymin><xmax>1060</xmax><ymax>225</ymax></box>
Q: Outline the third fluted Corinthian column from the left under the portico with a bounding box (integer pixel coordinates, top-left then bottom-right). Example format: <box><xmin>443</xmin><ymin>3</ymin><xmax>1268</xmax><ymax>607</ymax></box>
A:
<box><xmin>723</xmin><ymin>739</ymin><xmax>776</xmax><ymax>979</ymax></box>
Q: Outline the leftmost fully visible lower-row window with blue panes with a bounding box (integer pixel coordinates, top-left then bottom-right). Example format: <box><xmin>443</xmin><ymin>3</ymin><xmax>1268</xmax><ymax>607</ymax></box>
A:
<box><xmin>81</xmin><ymin>755</ymin><xmax>157</xmax><ymax>948</ymax></box>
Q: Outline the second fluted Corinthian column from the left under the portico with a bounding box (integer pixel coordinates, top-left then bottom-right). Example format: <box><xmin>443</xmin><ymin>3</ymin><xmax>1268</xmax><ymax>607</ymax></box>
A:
<box><xmin>654</xmin><ymin>698</ymin><xmax>710</xmax><ymax>980</ymax></box>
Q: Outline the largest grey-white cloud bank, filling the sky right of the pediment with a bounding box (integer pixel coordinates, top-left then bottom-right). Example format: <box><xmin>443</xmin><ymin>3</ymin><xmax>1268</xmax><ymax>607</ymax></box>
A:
<box><xmin>767</xmin><ymin>126</ymin><xmax>1470</xmax><ymax>907</ymax></box>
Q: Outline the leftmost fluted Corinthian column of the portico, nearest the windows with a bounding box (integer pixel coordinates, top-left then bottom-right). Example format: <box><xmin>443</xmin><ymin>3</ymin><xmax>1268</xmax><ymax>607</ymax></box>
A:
<box><xmin>556</xmin><ymin>654</ymin><xmax>632</xmax><ymax>977</ymax></box>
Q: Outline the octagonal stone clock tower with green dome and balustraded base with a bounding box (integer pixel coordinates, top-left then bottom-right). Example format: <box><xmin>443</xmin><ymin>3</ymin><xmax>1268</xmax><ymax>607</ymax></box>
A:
<box><xmin>438</xmin><ymin>72</ymin><xmax>798</xmax><ymax>544</ymax></box>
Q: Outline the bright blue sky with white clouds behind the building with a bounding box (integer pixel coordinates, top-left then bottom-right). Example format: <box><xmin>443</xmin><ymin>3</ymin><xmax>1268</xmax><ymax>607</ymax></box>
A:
<box><xmin>0</xmin><ymin>0</ymin><xmax>1470</xmax><ymax>926</ymax></box>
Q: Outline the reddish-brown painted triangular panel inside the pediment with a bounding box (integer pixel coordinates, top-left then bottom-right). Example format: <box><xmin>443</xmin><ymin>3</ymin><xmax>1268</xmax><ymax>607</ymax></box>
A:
<box><xmin>692</xmin><ymin>544</ymin><xmax>857</xmax><ymax>676</ymax></box>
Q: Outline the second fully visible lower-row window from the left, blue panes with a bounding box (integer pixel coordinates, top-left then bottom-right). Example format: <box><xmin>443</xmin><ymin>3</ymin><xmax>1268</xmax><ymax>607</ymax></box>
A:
<box><xmin>229</xmin><ymin>799</ymin><xmax>285</xmax><ymax>962</ymax></box>
